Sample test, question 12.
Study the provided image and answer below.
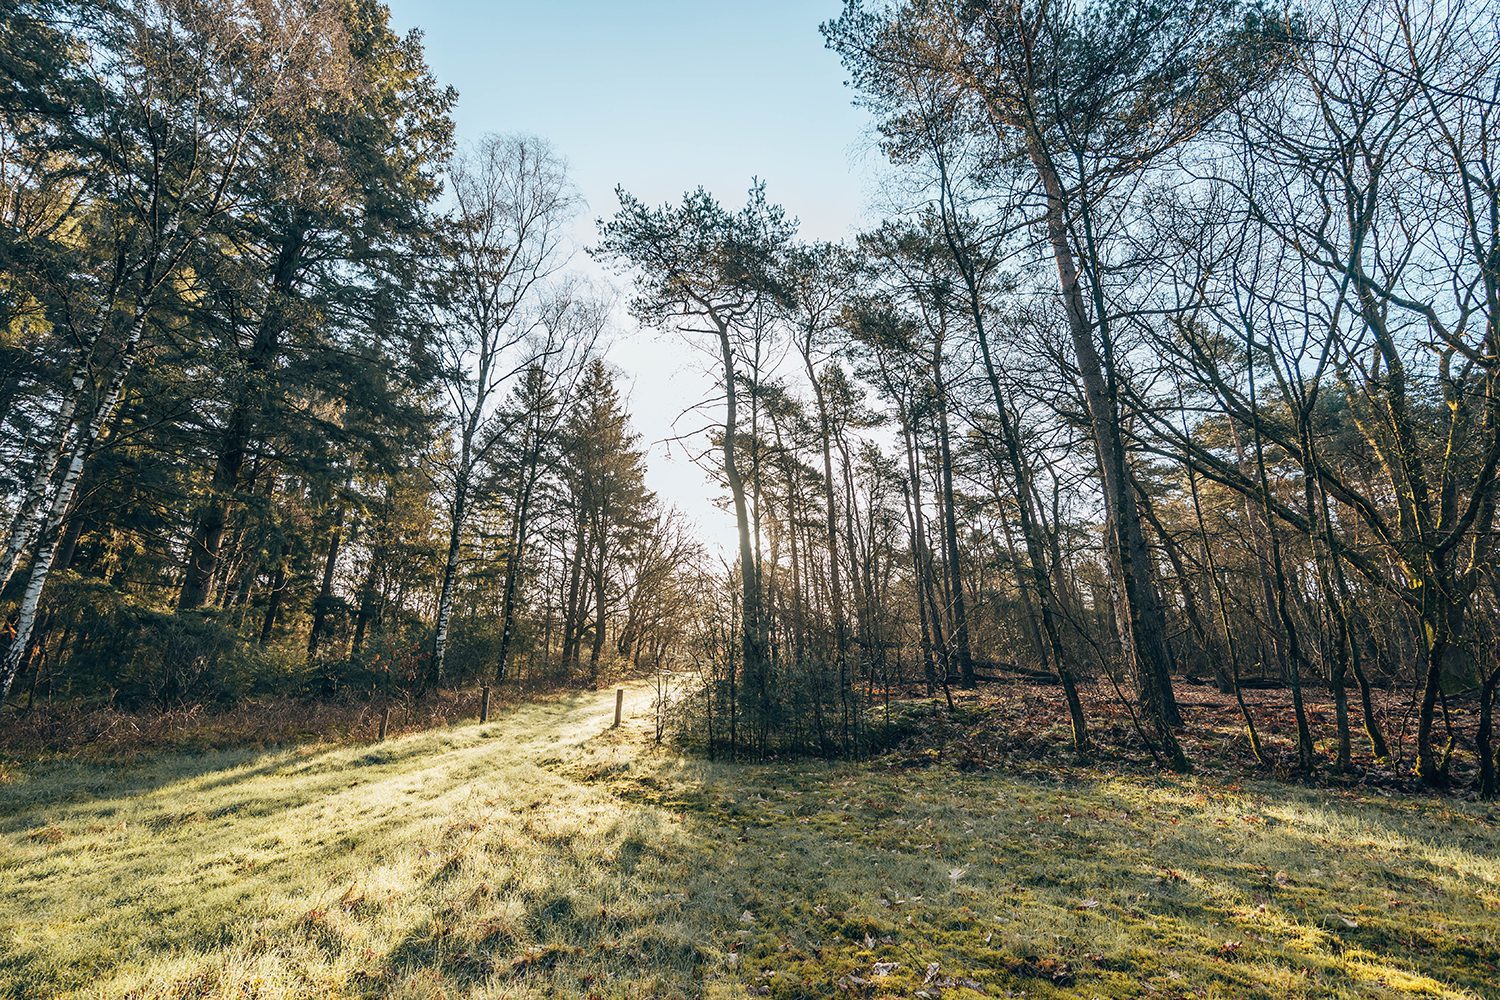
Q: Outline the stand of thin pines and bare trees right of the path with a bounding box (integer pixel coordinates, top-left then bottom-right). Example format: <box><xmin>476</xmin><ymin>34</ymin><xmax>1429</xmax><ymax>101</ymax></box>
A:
<box><xmin>600</xmin><ymin>0</ymin><xmax>1500</xmax><ymax>795</ymax></box>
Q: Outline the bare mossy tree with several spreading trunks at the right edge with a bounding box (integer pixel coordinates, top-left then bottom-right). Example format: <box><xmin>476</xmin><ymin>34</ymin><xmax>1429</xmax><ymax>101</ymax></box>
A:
<box><xmin>1140</xmin><ymin>1</ymin><xmax>1500</xmax><ymax>786</ymax></box>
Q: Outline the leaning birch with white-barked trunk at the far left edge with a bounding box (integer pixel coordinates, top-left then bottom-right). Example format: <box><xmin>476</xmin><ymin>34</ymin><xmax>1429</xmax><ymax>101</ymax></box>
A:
<box><xmin>0</xmin><ymin>0</ymin><xmax>347</xmax><ymax>697</ymax></box>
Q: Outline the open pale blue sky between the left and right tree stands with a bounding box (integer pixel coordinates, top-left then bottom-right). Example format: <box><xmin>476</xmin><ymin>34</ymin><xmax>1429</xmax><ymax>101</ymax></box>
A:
<box><xmin>390</xmin><ymin>0</ymin><xmax>876</xmax><ymax>544</ymax></box>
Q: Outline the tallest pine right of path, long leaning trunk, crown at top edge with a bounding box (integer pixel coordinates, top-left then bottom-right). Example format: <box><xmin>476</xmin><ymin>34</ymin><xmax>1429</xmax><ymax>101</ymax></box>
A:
<box><xmin>824</xmin><ymin>0</ymin><xmax>1280</xmax><ymax>765</ymax></box>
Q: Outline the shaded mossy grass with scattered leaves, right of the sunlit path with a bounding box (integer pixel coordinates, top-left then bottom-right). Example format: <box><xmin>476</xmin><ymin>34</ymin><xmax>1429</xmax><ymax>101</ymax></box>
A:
<box><xmin>687</xmin><ymin>768</ymin><xmax>1500</xmax><ymax>997</ymax></box>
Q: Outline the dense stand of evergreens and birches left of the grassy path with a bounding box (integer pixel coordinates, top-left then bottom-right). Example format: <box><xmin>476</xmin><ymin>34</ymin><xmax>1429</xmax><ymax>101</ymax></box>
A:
<box><xmin>0</xmin><ymin>0</ymin><xmax>692</xmax><ymax>708</ymax></box>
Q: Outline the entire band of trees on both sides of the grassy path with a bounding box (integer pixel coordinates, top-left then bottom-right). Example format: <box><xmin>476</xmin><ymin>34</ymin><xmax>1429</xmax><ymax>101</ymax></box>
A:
<box><xmin>0</xmin><ymin>0</ymin><xmax>1500</xmax><ymax>796</ymax></box>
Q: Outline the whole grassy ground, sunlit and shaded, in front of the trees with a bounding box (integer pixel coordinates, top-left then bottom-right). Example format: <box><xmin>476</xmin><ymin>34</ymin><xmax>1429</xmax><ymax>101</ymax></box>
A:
<box><xmin>0</xmin><ymin>687</ymin><xmax>1500</xmax><ymax>1000</ymax></box>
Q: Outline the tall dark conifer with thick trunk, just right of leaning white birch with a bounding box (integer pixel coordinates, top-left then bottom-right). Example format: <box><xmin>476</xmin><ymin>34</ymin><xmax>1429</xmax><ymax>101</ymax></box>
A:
<box><xmin>179</xmin><ymin>0</ymin><xmax>453</xmax><ymax>609</ymax></box>
